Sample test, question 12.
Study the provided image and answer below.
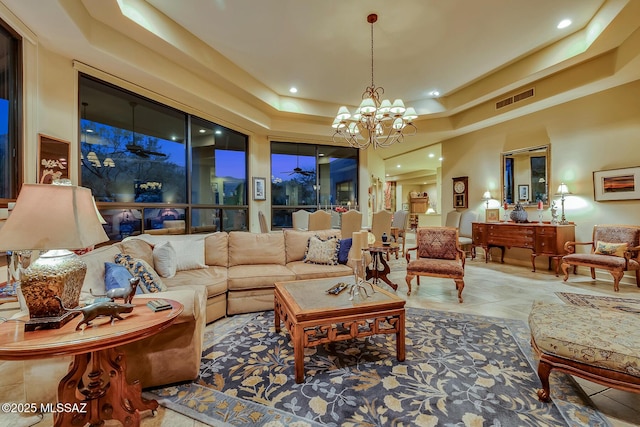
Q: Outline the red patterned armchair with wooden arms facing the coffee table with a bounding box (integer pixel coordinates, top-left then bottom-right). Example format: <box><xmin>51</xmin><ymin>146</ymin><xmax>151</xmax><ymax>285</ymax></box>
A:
<box><xmin>406</xmin><ymin>227</ymin><xmax>465</xmax><ymax>302</ymax></box>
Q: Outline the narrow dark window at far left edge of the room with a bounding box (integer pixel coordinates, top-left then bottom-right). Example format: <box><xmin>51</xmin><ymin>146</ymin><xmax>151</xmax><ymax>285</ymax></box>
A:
<box><xmin>0</xmin><ymin>21</ymin><xmax>22</xmax><ymax>200</ymax></box>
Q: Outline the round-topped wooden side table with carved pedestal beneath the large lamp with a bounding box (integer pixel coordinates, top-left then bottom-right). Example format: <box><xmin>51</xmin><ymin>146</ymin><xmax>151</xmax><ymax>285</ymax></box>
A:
<box><xmin>0</xmin><ymin>298</ymin><xmax>183</xmax><ymax>427</ymax></box>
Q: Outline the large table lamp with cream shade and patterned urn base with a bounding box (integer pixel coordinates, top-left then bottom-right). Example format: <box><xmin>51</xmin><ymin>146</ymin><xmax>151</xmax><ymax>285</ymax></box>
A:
<box><xmin>0</xmin><ymin>184</ymin><xmax>109</xmax><ymax>331</ymax></box>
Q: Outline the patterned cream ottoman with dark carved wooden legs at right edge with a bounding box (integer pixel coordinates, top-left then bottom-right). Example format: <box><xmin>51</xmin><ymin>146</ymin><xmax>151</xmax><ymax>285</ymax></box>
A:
<box><xmin>529</xmin><ymin>301</ymin><xmax>640</xmax><ymax>402</ymax></box>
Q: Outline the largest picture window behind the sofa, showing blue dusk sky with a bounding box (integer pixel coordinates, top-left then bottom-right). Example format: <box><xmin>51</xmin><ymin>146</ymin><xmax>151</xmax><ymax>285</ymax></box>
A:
<box><xmin>79</xmin><ymin>75</ymin><xmax>247</xmax><ymax>240</ymax></box>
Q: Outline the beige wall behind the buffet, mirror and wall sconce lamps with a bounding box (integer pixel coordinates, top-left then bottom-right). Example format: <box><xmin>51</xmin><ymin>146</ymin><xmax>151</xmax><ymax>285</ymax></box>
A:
<box><xmin>442</xmin><ymin>81</ymin><xmax>640</xmax><ymax>278</ymax></box>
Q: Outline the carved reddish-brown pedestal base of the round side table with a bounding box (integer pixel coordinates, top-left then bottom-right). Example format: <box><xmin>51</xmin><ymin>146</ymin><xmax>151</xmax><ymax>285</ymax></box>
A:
<box><xmin>54</xmin><ymin>348</ymin><xmax>158</xmax><ymax>427</ymax></box>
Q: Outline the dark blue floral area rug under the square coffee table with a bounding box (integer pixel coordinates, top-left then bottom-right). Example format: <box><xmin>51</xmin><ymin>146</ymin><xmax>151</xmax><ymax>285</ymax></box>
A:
<box><xmin>145</xmin><ymin>308</ymin><xmax>608</xmax><ymax>427</ymax></box>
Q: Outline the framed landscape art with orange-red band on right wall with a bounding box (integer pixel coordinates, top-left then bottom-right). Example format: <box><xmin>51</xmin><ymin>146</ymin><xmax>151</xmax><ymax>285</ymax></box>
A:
<box><xmin>593</xmin><ymin>166</ymin><xmax>640</xmax><ymax>202</ymax></box>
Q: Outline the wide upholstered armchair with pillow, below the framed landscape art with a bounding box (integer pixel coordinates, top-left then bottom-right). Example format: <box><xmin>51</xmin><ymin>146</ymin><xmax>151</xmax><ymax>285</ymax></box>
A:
<box><xmin>562</xmin><ymin>225</ymin><xmax>640</xmax><ymax>292</ymax></box>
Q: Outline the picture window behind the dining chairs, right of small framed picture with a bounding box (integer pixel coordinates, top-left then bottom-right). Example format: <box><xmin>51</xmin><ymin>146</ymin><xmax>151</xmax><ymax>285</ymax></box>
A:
<box><xmin>271</xmin><ymin>142</ymin><xmax>358</xmax><ymax>228</ymax></box>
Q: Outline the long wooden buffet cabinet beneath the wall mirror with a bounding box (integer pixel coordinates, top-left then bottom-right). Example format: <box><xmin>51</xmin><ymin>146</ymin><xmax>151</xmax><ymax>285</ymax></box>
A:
<box><xmin>472</xmin><ymin>222</ymin><xmax>576</xmax><ymax>276</ymax></box>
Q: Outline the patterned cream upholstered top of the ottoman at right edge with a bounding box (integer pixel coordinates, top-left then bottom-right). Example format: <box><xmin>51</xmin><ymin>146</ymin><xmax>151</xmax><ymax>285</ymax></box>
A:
<box><xmin>529</xmin><ymin>301</ymin><xmax>640</xmax><ymax>377</ymax></box>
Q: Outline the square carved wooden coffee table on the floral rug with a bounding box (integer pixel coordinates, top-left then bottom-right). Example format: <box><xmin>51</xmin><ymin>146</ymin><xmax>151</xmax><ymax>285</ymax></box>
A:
<box><xmin>275</xmin><ymin>276</ymin><xmax>405</xmax><ymax>383</ymax></box>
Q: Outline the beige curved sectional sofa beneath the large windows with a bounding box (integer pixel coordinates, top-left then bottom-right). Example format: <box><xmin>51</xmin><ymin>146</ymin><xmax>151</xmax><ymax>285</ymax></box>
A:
<box><xmin>25</xmin><ymin>230</ymin><xmax>360</xmax><ymax>402</ymax></box>
